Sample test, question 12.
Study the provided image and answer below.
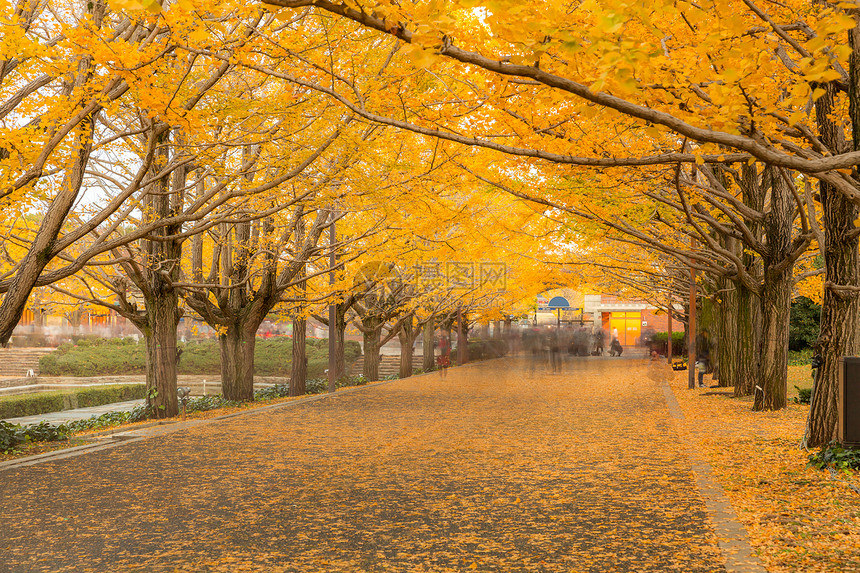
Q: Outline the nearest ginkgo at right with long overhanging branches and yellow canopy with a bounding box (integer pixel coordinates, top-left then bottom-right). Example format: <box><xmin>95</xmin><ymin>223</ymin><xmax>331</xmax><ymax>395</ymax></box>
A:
<box><xmin>235</xmin><ymin>0</ymin><xmax>860</xmax><ymax>444</ymax></box>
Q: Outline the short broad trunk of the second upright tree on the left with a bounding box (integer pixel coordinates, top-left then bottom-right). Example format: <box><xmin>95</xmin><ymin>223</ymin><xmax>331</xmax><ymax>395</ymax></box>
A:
<box><xmin>218</xmin><ymin>324</ymin><xmax>257</xmax><ymax>401</ymax></box>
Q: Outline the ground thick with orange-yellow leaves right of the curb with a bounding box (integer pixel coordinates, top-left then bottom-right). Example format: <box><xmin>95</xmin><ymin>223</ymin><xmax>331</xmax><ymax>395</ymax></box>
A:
<box><xmin>672</xmin><ymin>372</ymin><xmax>860</xmax><ymax>572</ymax></box>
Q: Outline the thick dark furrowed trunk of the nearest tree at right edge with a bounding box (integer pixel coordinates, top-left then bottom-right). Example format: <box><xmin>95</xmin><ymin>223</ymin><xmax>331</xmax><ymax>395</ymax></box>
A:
<box><xmin>806</xmin><ymin>79</ymin><xmax>860</xmax><ymax>447</ymax></box>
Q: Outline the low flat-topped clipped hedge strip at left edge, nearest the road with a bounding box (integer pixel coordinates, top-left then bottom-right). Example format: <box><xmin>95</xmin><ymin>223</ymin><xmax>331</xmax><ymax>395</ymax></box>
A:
<box><xmin>0</xmin><ymin>384</ymin><xmax>146</xmax><ymax>419</ymax></box>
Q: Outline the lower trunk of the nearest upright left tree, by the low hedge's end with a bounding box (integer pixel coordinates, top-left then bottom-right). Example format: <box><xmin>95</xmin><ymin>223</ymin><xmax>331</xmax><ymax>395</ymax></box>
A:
<box><xmin>143</xmin><ymin>290</ymin><xmax>179</xmax><ymax>418</ymax></box>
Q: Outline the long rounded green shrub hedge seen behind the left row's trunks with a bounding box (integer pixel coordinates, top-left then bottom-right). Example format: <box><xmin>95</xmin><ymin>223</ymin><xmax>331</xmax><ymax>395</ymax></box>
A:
<box><xmin>39</xmin><ymin>337</ymin><xmax>361</xmax><ymax>378</ymax></box>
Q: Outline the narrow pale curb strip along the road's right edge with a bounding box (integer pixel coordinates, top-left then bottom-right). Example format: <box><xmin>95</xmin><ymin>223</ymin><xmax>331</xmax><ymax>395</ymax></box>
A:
<box><xmin>660</xmin><ymin>380</ymin><xmax>767</xmax><ymax>573</ymax></box>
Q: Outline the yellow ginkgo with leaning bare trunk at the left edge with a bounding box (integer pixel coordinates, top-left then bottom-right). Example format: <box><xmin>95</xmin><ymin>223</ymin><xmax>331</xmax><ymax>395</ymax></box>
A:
<box><xmin>0</xmin><ymin>0</ymin><xmax>266</xmax><ymax>343</ymax></box>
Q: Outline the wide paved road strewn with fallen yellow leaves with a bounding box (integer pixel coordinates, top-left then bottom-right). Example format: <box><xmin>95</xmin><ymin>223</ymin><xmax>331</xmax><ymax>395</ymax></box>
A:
<box><xmin>0</xmin><ymin>358</ymin><xmax>744</xmax><ymax>573</ymax></box>
